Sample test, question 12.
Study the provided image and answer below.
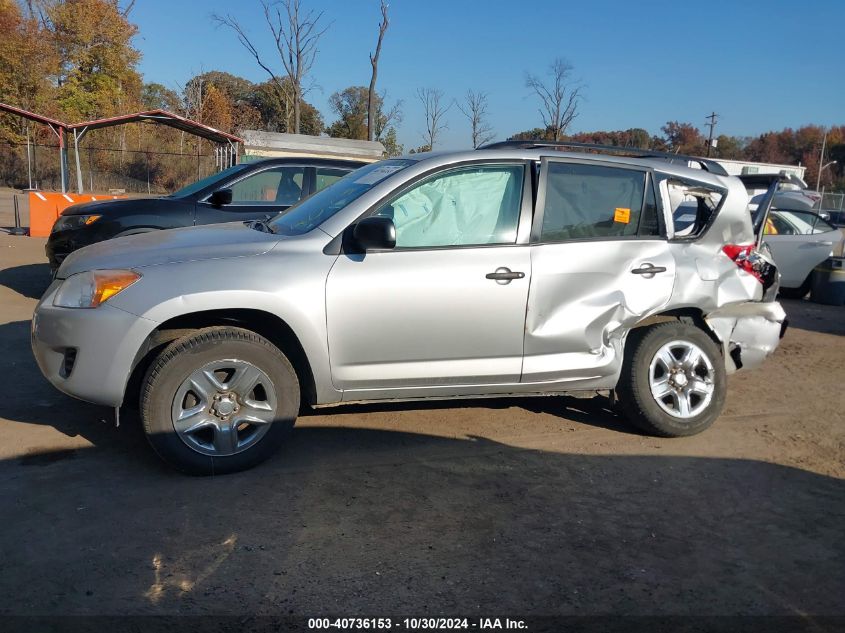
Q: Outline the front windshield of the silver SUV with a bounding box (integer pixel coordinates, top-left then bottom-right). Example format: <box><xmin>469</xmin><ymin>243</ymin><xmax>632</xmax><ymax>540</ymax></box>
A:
<box><xmin>270</xmin><ymin>159</ymin><xmax>414</xmax><ymax>235</ymax></box>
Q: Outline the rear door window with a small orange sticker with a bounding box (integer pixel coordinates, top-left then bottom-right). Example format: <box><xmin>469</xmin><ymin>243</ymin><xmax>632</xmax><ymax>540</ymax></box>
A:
<box><xmin>540</xmin><ymin>162</ymin><xmax>648</xmax><ymax>242</ymax></box>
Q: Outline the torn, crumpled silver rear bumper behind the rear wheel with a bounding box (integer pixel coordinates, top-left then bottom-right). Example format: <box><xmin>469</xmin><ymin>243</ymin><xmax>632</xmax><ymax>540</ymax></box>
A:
<box><xmin>705</xmin><ymin>301</ymin><xmax>787</xmax><ymax>374</ymax></box>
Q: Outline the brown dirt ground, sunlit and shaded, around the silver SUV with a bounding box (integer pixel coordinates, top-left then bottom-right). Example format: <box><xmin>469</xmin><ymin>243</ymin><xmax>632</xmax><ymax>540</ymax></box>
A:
<box><xmin>0</xmin><ymin>227</ymin><xmax>845</xmax><ymax>630</ymax></box>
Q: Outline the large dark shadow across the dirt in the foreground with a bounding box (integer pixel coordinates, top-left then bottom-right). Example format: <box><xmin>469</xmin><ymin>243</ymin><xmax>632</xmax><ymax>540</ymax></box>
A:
<box><xmin>0</xmin><ymin>427</ymin><xmax>845</xmax><ymax>630</ymax></box>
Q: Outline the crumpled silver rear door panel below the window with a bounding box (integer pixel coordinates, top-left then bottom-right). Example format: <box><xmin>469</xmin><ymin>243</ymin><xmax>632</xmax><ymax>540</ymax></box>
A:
<box><xmin>522</xmin><ymin>239</ymin><xmax>675</xmax><ymax>382</ymax></box>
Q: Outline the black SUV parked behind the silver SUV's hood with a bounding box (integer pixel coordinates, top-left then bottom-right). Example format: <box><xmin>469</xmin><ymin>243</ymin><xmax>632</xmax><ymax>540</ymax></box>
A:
<box><xmin>46</xmin><ymin>158</ymin><xmax>366</xmax><ymax>273</ymax></box>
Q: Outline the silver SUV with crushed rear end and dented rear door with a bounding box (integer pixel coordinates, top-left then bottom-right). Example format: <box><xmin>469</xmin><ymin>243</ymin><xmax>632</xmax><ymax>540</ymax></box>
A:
<box><xmin>32</xmin><ymin>143</ymin><xmax>785</xmax><ymax>474</ymax></box>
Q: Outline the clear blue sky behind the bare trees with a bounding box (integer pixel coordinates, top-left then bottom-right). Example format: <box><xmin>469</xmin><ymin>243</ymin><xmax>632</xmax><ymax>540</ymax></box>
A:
<box><xmin>131</xmin><ymin>0</ymin><xmax>845</xmax><ymax>150</ymax></box>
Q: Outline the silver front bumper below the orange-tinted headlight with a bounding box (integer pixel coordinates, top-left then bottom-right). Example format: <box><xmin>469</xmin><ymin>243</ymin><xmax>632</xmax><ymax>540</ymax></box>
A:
<box><xmin>31</xmin><ymin>281</ymin><xmax>157</xmax><ymax>407</ymax></box>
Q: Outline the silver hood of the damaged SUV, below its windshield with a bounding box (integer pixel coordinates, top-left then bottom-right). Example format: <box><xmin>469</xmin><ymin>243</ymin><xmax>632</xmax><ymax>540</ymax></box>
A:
<box><xmin>56</xmin><ymin>222</ymin><xmax>284</xmax><ymax>279</ymax></box>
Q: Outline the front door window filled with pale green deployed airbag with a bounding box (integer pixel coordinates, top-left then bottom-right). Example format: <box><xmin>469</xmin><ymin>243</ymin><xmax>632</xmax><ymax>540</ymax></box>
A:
<box><xmin>377</xmin><ymin>165</ymin><xmax>525</xmax><ymax>249</ymax></box>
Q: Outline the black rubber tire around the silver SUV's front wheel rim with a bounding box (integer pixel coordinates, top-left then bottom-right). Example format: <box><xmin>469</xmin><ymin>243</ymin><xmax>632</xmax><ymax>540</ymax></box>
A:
<box><xmin>140</xmin><ymin>327</ymin><xmax>300</xmax><ymax>475</ymax></box>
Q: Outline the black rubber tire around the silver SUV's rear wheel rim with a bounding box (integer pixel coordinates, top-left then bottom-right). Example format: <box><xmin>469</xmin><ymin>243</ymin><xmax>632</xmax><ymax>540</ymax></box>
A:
<box><xmin>616</xmin><ymin>321</ymin><xmax>727</xmax><ymax>437</ymax></box>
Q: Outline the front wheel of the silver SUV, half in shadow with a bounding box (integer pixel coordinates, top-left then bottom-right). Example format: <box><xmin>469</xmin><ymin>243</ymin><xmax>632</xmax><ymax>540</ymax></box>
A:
<box><xmin>141</xmin><ymin>327</ymin><xmax>299</xmax><ymax>475</ymax></box>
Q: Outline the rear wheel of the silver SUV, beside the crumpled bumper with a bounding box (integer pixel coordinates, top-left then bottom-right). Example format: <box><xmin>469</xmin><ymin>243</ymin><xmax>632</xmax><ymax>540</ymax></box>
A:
<box><xmin>616</xmin><ymin>322</ymin><xmax>727</xmax><ymax>437</ymax></box>
